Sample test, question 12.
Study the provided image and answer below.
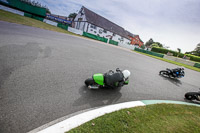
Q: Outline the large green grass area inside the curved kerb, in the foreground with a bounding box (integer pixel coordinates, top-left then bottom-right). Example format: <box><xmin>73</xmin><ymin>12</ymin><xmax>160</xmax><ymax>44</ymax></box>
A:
<box><xmin>69</xmin><ymin>104</ymin><xmax>200</xmax><ymax>133</ymax></box>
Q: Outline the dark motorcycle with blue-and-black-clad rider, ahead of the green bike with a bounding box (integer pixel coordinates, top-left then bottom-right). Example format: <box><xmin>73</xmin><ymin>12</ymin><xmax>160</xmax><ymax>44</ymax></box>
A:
<box><xmin>159</xmin><ymin>68</ymin><xmax>185</xmax><ymax>78</ymax></box>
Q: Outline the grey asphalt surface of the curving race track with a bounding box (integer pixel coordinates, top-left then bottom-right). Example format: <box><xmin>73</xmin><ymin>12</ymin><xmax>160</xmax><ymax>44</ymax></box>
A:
<box><xmin>0</xmin><ymin>21</ymin><xmax>200</xmax><ymax>133</ymax></box>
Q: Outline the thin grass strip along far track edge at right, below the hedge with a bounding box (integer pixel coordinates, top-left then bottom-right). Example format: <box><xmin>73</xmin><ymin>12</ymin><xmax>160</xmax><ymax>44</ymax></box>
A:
<box><xmin>134</xmin><ymin>51</ymin><xmax>200</xmax><ymax>72</ymax></box>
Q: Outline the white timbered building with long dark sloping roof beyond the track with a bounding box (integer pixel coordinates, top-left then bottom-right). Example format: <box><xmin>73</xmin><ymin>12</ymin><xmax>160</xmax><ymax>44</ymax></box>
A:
<box><xmin>74</xmin><ymin>6</ymin><xmax>130</xmax><ymax>44</ymax></box>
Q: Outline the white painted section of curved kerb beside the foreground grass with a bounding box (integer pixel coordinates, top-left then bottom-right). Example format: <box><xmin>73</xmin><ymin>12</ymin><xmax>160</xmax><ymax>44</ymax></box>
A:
<box><xmin>38</xmin><ymin>101</ymin><xmax>145</xmax><ymax>133</ymax></box>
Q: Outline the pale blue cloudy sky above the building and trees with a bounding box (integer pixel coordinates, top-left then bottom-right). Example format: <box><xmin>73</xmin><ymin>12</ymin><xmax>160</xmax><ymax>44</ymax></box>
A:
<box><xmin>35</xmin><ymin>0</ymin><xmax>200</xmax><ymax>53</ymax></box>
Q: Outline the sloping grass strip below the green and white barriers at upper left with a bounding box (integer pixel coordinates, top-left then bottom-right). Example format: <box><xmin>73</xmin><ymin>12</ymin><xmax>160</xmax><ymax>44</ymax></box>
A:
<box><xmin>0</xmin><ymin>10</ymin><xmax>79</xmax><ymax>36</ymax></box>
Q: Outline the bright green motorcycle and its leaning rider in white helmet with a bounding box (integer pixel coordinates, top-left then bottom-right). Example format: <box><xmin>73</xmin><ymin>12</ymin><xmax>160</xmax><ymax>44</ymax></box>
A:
<box><xmin>85</xmin><ymin>68</ymin><xmax>131</xmax><ymax>89</ymax></box>
